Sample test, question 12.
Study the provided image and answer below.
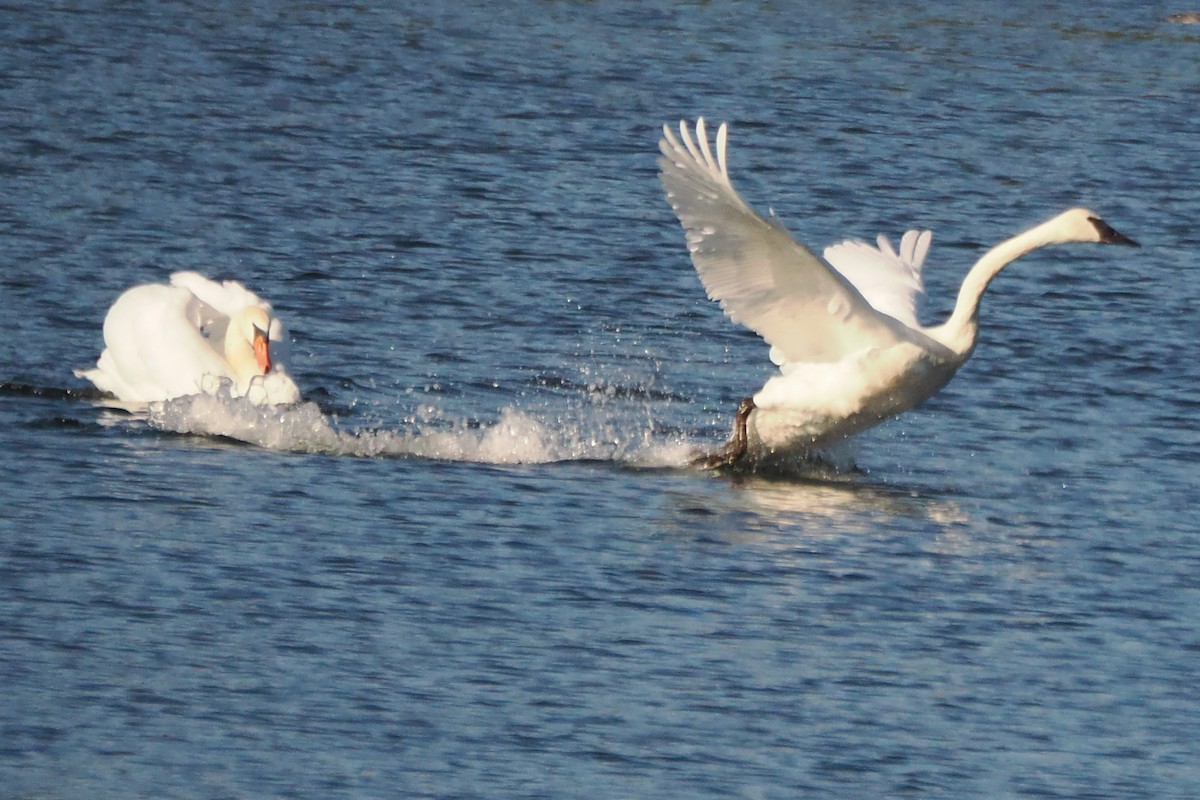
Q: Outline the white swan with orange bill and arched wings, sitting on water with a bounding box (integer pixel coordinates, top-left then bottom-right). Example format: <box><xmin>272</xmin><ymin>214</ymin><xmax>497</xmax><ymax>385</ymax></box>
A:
<box><xmin>76</xmin><ymin>272</ymin><xmax>300</xmax><ymax>405</ymax></box>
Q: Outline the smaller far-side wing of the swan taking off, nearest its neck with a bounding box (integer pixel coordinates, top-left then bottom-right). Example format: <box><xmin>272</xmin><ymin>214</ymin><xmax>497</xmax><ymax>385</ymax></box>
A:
<box><xmin>824</xmin><ymin>230</ymin><xmax>934</xmax><ymax>327</ymax></box>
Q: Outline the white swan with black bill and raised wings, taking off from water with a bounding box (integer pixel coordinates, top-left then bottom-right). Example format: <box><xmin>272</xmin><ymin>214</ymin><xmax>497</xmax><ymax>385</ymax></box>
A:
<box><xmin>659</xmin><ymin>119</ymin><xmax>1136</xmax><ymax>468</ymax></box>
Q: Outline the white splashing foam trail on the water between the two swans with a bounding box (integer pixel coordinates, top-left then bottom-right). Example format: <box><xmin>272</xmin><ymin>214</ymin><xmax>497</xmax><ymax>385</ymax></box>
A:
<box><xmin>148</xmin><ymin>392</ymin><xmax>697</xmax><ymax>468</ymax></box>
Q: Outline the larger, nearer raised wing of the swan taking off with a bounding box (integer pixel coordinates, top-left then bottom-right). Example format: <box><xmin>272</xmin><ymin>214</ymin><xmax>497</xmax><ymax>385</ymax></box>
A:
<box><xmin>659</xmin><ymin>119</ymin><xmax>905</xmax><ymax>363</ymax></box>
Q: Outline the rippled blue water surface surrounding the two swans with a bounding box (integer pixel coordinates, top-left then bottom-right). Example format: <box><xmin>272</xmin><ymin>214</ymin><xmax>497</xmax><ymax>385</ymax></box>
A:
<box><xmin>0</xmin><ymin>0</ymin><xmax>1200</xmax><ymax>800</ymax></box>
